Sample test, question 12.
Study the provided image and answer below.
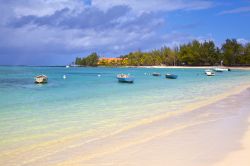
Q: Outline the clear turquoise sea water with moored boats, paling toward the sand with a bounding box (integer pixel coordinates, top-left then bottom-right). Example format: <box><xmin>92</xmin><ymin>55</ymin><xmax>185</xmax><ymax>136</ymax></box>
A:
<box><xmin>0</xmin><ymin>67</ymin><xmax>250</xmax><ymax>150</ymax></box>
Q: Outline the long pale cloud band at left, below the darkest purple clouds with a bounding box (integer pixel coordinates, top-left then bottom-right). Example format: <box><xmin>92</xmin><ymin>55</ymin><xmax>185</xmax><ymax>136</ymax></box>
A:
<box><xmin>0</xmin><ymin>22</ymin><xmax>157</xmax><ymax>54</ymax></box>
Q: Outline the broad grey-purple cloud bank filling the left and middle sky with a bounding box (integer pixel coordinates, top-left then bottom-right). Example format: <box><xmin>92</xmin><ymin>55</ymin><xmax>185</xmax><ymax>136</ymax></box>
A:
<box><xmin>0</xmin><ymin>0</ymin><xmax>215</xmax><ymax>64</ymax></box>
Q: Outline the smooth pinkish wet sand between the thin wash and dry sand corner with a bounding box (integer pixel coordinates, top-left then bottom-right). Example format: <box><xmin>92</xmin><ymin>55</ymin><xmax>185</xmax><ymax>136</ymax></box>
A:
<box><xmin>52</xmin><ymin>86</ymin><xmax>250</xmax><ymax>166</ymax></box>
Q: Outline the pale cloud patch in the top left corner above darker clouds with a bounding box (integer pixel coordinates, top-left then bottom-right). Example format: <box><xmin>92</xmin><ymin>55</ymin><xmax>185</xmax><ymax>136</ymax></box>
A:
<box><xmin>0</xmin><ymin>0</ymin><xmax>86</xmax><ymax>26</ymax></box>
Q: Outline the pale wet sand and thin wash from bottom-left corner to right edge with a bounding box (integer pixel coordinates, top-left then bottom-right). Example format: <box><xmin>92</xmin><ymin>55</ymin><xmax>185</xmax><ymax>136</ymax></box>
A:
<box><xmin>0</xmin><ymin>84</ymin><xmax>250</xmax><ymax>166</ymax></box>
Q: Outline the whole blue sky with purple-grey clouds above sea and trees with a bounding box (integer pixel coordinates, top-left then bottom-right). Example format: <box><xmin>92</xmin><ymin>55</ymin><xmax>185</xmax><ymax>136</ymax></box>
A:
<box><xmin>0</xmin><ymin>0</ymin><xmax>250</xmax><ymax>65</ymax></box>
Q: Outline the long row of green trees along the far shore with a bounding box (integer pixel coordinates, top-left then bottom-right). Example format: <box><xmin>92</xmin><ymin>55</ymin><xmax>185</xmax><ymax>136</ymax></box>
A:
<box><xmin>75</xmin><ymin>39</ymin><xmax>250</xmax><ymax>66</ymax></box>
